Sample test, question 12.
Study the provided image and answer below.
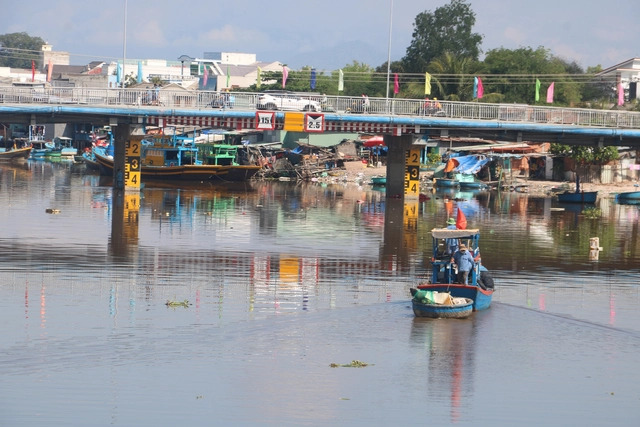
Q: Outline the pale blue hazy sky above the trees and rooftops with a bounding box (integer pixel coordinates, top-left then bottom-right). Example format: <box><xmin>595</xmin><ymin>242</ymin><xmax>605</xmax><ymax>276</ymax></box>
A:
<box><xmin>5</xmin><ymin>0</ymin><xmax>640</xmax><ymax>70</ymax></box>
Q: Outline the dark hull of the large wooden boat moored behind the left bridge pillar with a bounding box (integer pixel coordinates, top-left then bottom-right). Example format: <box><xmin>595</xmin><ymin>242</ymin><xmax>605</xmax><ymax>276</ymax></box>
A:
<box><xmin>95</xmin><ymin>153</ymin><xmax>260</xmax><ymax>182</ymax></box>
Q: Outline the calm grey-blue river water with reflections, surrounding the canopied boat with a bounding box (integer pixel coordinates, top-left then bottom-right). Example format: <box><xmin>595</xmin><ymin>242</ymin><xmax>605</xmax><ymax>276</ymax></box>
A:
<box><xmin>0</xmin><ymin>161</ymin><xmax>640</xmax><ymax>426</ymax></box>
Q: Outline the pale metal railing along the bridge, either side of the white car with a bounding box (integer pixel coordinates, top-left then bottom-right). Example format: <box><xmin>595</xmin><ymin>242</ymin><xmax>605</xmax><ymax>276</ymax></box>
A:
<box><xmin>0</xmin><ymin>86</ymin><xmax>640</xmax><ymax>129</ymax></box>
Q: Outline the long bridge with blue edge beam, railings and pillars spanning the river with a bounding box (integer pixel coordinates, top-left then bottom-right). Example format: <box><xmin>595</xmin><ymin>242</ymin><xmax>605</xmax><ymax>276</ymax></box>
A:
<box><xmin>0</xmin><ymin>87</ymin><xmax>640</xmax><ymax>194</ymax></box>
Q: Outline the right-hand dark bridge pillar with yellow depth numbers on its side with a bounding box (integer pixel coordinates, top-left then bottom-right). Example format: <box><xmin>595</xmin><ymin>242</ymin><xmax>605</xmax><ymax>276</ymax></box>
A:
<box><xmin>384</xmin><ymin>135</ymin><xmax>420</xmax><ymax>198</ymax></box>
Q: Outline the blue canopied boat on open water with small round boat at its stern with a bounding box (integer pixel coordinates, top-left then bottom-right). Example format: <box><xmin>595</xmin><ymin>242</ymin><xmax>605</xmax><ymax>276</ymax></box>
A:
<box><xmin>412</xmin><ymin>228</ymin><xmax>494</xmax><ymax>317</ymax></box>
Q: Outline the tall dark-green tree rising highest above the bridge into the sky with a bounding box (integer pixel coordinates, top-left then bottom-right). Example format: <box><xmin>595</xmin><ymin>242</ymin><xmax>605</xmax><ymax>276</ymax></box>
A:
<box><xmin>402</xmin><ymin>0</ymin><xmax>482</xmax><ymax>73</ymax></box>
